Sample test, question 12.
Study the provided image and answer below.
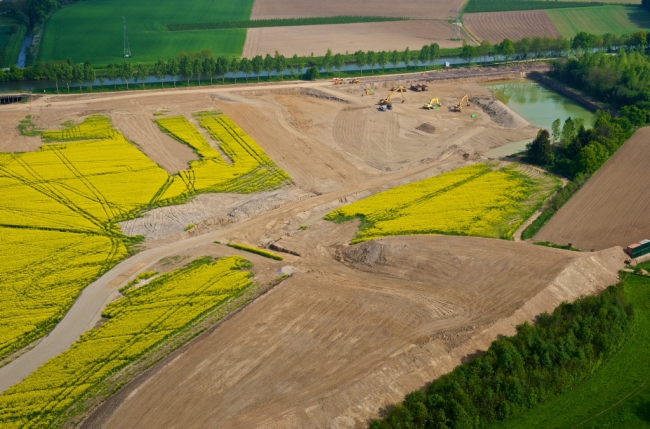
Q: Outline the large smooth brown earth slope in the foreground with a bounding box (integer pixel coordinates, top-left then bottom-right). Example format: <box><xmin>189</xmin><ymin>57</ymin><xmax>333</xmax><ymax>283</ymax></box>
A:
<box><xmin>84</xmin><ymin>229</ymin><xmax>624</xmax><ymax>428</ymax></box>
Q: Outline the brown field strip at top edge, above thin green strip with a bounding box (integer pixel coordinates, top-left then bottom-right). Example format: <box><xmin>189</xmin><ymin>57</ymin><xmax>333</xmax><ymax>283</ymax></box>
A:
<box><xmin>251</xmin><ymin>0</ymin><xmax>465</xmax><ymax>20</ymax></box>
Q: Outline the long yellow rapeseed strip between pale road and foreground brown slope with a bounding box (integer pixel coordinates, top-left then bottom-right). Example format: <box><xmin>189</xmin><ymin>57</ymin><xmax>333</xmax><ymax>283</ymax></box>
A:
<box><xmin>0</xmin><ymin>256</ymin><xmax>253</xmax><ymax>429</ymax></box>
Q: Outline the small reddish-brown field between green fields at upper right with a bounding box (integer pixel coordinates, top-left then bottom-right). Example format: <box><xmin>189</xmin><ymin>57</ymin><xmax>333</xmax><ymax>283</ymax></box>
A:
<box><xmin>463</xmin><ymin>10</ymin><xmax>560</xmax><ymax>43</ymax></box>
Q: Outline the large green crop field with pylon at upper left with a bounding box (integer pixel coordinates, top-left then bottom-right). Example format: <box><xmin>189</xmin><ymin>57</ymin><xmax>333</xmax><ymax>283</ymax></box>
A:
<box><xmin>38</xmin><ymin>0</ymin><xmax>253</xmax><ymax>65</ymax></box>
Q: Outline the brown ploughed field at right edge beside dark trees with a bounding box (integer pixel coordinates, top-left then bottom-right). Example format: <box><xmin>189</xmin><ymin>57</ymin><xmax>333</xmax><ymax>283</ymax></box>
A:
<box><xmin>535</xmin><ymin>127</ymin><xmax>650</xmax><ymax>250</ymax></box>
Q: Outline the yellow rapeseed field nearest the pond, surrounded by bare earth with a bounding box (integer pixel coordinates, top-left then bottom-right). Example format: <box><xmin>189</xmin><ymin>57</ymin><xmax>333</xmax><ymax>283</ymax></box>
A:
<box><xmin>326</xmin><ymin>164</ymin><xmax>559</xmax><ymax>243</ymax></box>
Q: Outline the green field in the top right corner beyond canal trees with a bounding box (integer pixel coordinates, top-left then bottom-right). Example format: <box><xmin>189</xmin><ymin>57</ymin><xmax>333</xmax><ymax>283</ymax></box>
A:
<box><xmin>546</xmin><ymin>5</ymin><xmax>650</xmax><ymax>37</ymax></box>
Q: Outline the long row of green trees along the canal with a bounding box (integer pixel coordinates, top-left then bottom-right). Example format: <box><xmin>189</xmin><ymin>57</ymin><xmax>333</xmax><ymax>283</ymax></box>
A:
<box><xmin>0</xmin><ymin>31</ymin><xmax>650</xmax><ymax>92</ymax></box>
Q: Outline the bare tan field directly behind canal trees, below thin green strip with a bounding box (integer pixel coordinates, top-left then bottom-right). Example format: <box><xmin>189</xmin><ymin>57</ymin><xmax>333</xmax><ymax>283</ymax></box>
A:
<box><xmin>243</xmin><ymin>20</ymin><xmax>471</xmax><ymax>58</ymax></box>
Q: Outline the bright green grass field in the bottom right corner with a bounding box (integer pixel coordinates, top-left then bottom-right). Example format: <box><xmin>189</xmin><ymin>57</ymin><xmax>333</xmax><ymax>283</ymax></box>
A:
<box><xmin>495</xmin><ymin>275</ymin><xmax>650</xmax><ymax>429</ymax></box>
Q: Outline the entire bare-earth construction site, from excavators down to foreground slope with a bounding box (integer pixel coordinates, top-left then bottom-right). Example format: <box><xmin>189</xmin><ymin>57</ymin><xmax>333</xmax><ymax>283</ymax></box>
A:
<box><xmin>0</xmin><ymin>70</ymin><xmax>626</xmax><ymax>428</ymax></box>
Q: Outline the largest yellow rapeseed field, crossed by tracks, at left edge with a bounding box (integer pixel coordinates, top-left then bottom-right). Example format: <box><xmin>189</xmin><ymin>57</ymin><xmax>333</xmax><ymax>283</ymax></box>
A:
<box><xmin>0</xmin><ymin>116</ymin><xmax>288</xmax><ymax>359</ymax></box>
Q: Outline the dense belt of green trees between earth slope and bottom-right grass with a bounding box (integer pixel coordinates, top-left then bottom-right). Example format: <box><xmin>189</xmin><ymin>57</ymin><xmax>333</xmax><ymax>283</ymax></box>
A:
<box><xmin>370</xmin><ymin>284</ymin><xmax>633</xmax><ymax>429</ymax></box>
